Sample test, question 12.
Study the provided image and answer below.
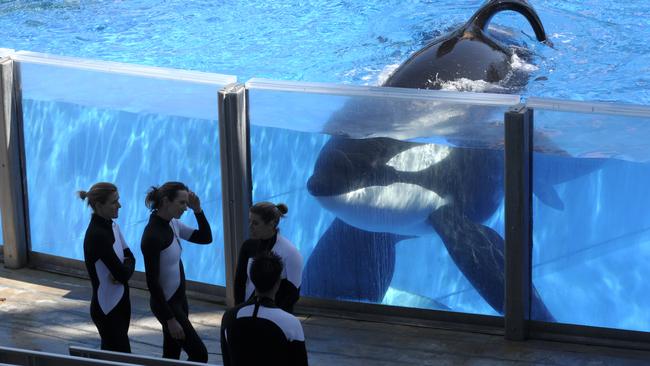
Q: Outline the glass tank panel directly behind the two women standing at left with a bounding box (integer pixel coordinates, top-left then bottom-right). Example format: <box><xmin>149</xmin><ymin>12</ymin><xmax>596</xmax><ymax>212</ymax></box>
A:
<box><xmin>16</xmin><ymin>52</ymin><xmax>235</xmax><ymax>285</ymax></box>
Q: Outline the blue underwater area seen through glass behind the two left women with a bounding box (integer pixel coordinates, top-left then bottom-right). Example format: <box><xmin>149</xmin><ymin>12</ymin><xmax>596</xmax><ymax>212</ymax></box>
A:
<box><xmin>23</xmin><ymin>100</ymin><xmax>225</xmax><ymax>285</ymax></box>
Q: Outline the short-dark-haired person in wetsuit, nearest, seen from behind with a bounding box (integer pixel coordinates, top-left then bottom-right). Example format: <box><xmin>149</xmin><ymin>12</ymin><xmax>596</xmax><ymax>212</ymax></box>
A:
<box><xmin>221</xmin><ymin>251</ymin><xmax>308</xmax><ymax>366</ymax></box>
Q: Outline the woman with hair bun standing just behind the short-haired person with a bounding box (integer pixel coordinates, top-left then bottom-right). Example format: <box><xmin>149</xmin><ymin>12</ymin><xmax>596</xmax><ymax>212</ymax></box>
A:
<box><xmin>235</xmin><ymin>202</ymin><xmax>302</xmax><ymax>313</ymax></box>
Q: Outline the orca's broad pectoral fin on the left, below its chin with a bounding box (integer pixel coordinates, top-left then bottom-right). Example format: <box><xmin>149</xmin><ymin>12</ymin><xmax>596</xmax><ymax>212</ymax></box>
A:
<box><xmin>301</xmin><ymin>218</ymin><xmax>405</xmax><ymax>302</ymax></box>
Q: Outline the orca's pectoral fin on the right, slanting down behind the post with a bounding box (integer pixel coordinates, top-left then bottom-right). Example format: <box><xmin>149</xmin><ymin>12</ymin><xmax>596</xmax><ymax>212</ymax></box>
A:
<box><xmin>429</xmin><ymin>206</ymin><xmax>553</xmax><ymax>321</ymax></box>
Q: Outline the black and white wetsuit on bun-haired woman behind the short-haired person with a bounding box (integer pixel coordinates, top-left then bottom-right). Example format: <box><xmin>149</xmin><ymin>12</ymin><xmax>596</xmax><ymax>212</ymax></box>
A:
<box><xmin>235</xmin><ymin>234</ymin><xmax>302</xmax><ymax>313</ymax></box>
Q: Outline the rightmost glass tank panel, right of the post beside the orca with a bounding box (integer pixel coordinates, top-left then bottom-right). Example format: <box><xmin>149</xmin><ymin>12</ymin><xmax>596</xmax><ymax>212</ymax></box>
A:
<box><xmin>528</xmin><ymin>98</ymin><xmax>650</xmax><ymax>332</ymax></box>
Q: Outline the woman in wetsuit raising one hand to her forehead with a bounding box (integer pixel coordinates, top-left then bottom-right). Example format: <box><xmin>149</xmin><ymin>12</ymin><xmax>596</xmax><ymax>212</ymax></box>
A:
<box><xmin>141</xmin><ymin>182</ymin><xmax>212</xmax><ymax>363</ymax></box>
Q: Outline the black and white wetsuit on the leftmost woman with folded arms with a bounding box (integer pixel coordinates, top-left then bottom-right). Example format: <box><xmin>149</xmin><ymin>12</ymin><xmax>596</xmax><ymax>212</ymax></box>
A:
<box><xmin>84</xmin><ymin>214</ymin><xmax>135</xmax><ymax>353</ymax></box>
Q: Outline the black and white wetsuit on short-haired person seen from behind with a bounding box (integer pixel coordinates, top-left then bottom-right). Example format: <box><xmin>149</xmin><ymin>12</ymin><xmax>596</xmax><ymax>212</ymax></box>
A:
<box><xmin>221</xmin><ymin>297</ymin><xmax>308</xmax><ymax>366</ymax></box>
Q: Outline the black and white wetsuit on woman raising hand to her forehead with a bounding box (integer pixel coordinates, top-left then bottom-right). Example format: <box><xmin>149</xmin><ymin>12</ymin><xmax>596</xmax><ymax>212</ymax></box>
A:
<box><xmin>141</xmin><ymin>212</ymin><xmax>212</xmax><ymax>362</ymax></box>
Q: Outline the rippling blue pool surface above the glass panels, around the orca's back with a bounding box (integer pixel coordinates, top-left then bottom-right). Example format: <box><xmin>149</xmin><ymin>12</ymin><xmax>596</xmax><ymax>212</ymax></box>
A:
<box><xmin>0</xmin><ymin>0</ymin><xmax>650</xmax><ymax>104</ymax></box>
